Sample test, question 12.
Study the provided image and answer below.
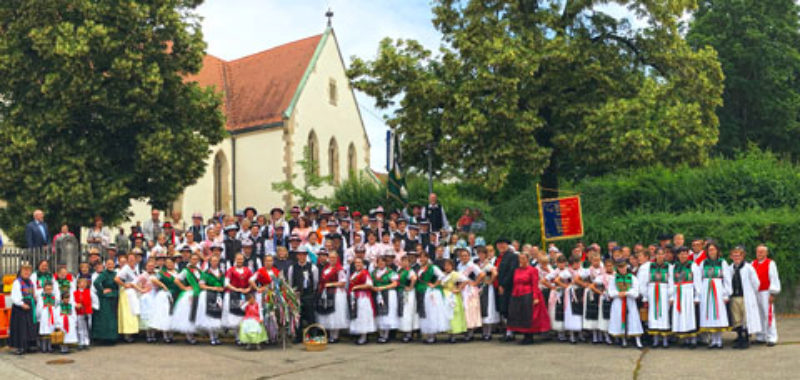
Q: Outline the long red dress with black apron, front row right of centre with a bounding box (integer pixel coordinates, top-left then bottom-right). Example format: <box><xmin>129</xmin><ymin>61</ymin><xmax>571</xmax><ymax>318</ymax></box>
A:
<box><xmin>508</xmin><ymin>265</ymin><xmax>550</xmax><ymax>334</ymax></box>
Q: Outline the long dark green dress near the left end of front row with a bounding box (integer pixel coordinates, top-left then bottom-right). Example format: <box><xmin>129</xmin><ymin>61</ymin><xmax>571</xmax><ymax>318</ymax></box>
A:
<box><xmin>92</xmin><ymin>269</ymin><xmax>119</xmax><ymax>342</ymax></box>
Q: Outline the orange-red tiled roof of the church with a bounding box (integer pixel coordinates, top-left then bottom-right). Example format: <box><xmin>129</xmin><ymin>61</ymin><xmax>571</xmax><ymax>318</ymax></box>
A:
<box><xmin>186</xmin><ymin>34</ymin><xmax>323</xmax><ymax>132</ymax></box>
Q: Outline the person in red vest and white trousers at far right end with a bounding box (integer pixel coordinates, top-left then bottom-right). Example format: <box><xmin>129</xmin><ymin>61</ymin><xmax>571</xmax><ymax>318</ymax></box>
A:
<box><xmin>751</xmin><ymin>244</ymin><xmax>781</xmax><ymax>347</ymax></box>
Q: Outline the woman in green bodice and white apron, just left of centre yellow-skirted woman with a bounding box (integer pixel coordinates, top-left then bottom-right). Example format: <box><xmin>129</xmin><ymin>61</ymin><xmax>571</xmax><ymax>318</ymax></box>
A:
<box><xmin>416</xmin><ymin>251</ymin><xmax>450</xmax><ymax>344</ymax></box>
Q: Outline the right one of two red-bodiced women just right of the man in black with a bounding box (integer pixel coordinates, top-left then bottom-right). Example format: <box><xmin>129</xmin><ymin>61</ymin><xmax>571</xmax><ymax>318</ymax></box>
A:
<box><xmin>348</xmin><ymin>257</ymin><xmax>375</xmax><ymax>345</ymax></box>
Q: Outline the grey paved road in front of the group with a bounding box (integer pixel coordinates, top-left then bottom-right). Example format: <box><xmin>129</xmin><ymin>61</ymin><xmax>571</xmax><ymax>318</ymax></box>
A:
<box><xmin>0</xmin><ymin>318</ymin><xmax>800</xmax><ymax>380</ymax></box>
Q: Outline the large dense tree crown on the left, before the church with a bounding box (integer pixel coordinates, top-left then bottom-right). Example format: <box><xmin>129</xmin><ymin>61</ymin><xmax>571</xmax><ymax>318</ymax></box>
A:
<box><xmin>0</xmin><ymin>0</ymin><xmax>225</xmax><ymax>243</ymax></box>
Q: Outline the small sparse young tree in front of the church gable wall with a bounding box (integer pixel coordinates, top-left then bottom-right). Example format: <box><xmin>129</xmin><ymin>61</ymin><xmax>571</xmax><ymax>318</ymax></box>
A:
<box><xmin>272</xmin><ymin>147</ymin><xmax>333</xmax><ymax>207</ymax></box>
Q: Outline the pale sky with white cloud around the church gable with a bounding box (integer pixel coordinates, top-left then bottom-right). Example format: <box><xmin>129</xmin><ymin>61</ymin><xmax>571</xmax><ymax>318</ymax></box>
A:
<box><xmin>197</xmin><ymin>0</ymin><xmax>644</xmax><ymax>172</ymax></box>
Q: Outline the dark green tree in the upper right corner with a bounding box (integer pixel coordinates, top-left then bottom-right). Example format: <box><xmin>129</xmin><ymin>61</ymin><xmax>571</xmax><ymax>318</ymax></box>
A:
<box><xmin>687</xmin><ymin>0</ymin><xmax>800</xmax><ymax>159</ymax></box>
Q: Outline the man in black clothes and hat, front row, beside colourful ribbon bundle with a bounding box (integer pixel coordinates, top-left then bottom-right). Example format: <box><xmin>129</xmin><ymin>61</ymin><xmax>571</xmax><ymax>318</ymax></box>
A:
<box><xmin>286</xmin><ymin>250</ymin><xmax>319</xmax><ymax>343</ymax></box>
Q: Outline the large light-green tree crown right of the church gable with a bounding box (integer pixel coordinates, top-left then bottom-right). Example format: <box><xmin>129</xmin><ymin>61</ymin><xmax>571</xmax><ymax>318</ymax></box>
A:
<box><xmin>348</xmin><ymin>0</ymin><xmax>722</xmax><ymax>196</ymax></box>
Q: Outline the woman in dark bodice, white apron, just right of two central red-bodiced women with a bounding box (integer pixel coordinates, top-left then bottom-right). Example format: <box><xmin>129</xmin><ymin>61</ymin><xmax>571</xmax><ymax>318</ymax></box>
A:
<box><xmin>372</xmin><ymin>256</ymin><xmax>400</xmax><ymax>344</ymax></box>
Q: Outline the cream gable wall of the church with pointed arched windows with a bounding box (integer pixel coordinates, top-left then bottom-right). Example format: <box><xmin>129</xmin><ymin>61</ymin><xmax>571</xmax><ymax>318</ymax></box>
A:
<box><xmin>290</xmin><ymin>32</ymin><xmax>369</xmax><ymax>203</ymax></box>
